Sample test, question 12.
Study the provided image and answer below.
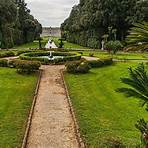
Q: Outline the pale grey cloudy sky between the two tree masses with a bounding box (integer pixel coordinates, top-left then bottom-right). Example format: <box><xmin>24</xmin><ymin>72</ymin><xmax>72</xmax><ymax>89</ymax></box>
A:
<box><xmin>26</xmin><ymin>0</ymin><xmax>79</xmax><ymax>27</ymax></box>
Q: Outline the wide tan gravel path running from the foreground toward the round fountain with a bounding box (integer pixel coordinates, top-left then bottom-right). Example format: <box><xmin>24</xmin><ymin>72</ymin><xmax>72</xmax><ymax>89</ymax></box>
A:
<box><xmin>27</xmin><ymin>66</ymin><xmax>78</xmax><ymax>148</ymax></box>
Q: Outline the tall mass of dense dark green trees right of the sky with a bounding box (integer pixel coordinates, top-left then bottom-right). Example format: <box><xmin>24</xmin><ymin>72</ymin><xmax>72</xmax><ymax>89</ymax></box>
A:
<box><xmin>61</xmin><ymin>0</ymin><xmax>148</xmax><ymax>48</ymax></box>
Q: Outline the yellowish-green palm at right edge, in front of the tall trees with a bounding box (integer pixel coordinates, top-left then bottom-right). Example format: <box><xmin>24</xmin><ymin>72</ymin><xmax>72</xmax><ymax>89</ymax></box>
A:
<box><xmin>127</xmin><ymin>22</ymin><xmax>148</xmax><ymax>50</ymax></box>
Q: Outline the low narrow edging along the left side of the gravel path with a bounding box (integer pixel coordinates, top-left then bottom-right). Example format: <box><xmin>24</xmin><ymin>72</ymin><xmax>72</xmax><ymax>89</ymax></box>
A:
<box><xmin>21</xmin><ymin>69</ymin><xmax>42</xmax><ymax>148</ymax></box>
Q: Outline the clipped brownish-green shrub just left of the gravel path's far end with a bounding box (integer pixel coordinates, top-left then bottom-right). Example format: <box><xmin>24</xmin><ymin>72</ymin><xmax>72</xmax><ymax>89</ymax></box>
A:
<box><xmin>14</xmin><ymin>60</ymin><xmax>41</xmax><ymax>74</ymax></box>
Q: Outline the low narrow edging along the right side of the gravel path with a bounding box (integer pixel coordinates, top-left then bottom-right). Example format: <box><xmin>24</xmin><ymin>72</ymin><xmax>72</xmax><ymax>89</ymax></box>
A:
<box><xmin>61</xmin><ymin>70</ymin><xmax>86</xmax><ymax>148</ymax></box>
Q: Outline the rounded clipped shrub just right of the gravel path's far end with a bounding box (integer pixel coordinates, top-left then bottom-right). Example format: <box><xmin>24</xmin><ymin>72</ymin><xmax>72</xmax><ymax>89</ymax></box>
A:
<box><xmin>66</xmin><ymin>60</ymin><xmax>90</xmax><ymax>73</ymax></box>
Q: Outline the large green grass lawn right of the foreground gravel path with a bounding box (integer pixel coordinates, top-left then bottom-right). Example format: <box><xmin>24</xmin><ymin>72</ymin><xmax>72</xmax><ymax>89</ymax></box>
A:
<box><xmin>65</xmin><ymin>62</ymin><xmax>148</xmax><ymax>148</ymax></box>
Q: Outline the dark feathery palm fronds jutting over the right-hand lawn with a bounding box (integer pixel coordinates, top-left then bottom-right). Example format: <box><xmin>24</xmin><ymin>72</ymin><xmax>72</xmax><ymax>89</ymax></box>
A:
<box><xmin>117</xmin><ymin>63</ymin><xmax>148</xmax><ymax>105</ymax></box>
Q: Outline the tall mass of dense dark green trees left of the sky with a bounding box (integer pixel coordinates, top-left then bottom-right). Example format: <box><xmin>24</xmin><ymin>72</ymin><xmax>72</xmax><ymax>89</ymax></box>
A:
<box><xmin>0</xmin><ymin>0</ymin><xmax>42</xmax><ymax>48</ymax></box>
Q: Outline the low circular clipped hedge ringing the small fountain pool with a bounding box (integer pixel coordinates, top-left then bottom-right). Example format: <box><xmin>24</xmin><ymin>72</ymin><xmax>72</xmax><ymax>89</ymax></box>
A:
<box><xmin>20</xmin><ymin>51</ymin><xmax>81</xmax><ymax>64</ymax></box>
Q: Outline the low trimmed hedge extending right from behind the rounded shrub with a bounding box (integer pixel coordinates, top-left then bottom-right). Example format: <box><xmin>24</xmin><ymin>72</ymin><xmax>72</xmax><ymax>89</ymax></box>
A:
<box><xmin>88</xmin><ymin>58</ymin><xmax>113</xmax><ymax>68</ymax></box>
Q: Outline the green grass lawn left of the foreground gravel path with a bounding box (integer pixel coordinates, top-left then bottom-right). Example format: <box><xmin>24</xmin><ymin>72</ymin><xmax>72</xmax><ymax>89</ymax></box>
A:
<box><xmin>0</xmin><ymin>68</ymin><xmax>37</xmax><ymax>148</ymax></box>
